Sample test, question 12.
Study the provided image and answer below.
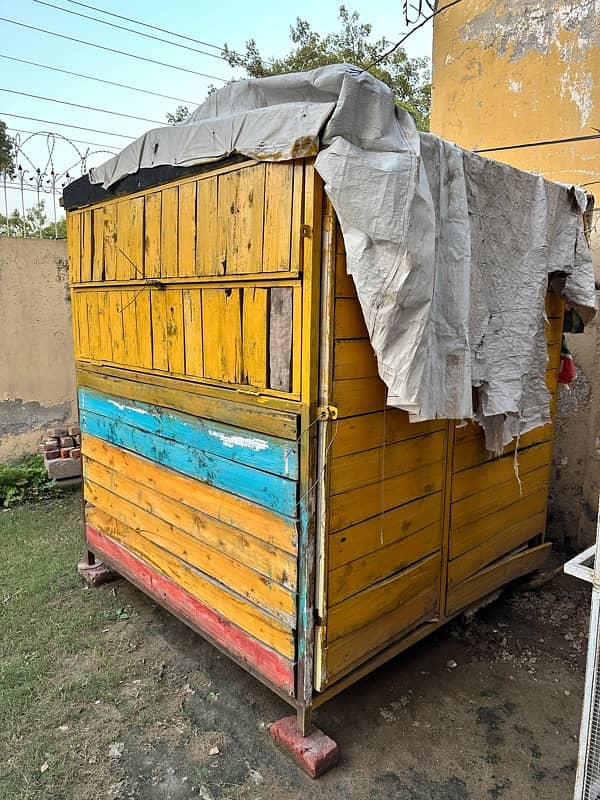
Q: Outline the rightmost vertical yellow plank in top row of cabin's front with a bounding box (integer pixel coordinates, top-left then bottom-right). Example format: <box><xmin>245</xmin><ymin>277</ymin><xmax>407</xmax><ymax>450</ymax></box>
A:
<box><xmin>262</xmin><ymin>161</ymin><xmax>294</xmax><ymax>272</ymax></box>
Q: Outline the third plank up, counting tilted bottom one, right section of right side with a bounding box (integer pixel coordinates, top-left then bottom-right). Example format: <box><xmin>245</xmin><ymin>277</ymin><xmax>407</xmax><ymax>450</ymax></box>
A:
<box><xmin>450</xmin><ymin>486</ymin><xmax>548</xmax><ymax>558</ymax></box>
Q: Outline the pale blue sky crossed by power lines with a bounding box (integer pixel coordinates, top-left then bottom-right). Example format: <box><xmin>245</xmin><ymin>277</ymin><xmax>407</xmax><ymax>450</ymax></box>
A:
<box><xmin>0</xmin><ymin>0</ymin><xmax>431</xmax><ymax>219</ymax></box>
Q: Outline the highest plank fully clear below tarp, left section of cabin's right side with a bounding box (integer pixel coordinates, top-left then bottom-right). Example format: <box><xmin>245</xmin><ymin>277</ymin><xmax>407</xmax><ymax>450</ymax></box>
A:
<box><xmin>330</xmin><ymin>431</ymin><xmax>446</xmax><ymax>494</ymax></box>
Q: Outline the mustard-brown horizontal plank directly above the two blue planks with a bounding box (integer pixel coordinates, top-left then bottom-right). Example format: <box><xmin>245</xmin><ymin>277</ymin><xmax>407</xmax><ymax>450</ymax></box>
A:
<box><xmin>77</xmin><ymin>368</ymin><xmax>298</xmax><ymax>440</ymax></box>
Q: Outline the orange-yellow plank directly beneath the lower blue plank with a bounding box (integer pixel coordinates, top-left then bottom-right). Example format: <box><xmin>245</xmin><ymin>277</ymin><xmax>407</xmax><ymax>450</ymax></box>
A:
<box><xmin>82</xmin><ymin>435</ymin><xmax>298</xmax><ymax>556</ymax></box>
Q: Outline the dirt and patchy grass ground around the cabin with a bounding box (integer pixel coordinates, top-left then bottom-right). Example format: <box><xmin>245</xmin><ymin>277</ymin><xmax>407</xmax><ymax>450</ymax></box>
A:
<box><xmin>0</xmin><ymin>500</ymin><xmax>590</xmax><ymax>800</ymax></box>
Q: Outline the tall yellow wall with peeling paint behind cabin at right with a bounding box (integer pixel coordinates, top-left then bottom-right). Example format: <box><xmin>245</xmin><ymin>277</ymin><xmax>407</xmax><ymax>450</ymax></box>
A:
<box><xmin>431</xmin><ymin>0</ymin><xmax>600</xmax><ymax>546</ymax></box>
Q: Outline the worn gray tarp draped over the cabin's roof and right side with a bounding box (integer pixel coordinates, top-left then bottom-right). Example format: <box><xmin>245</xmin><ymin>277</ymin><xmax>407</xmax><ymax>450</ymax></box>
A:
<box><xmin>90</xmin><ymin>65</ymin><xmax>595</xmax><ymax>452</ymax></box>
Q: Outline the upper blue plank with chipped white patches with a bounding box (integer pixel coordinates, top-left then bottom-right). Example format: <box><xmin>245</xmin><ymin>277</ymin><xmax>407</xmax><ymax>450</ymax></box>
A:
<box><xmin>79</xmin><ymin>388</ymin><xmax>298</xmax><ymax>480</ymax></box>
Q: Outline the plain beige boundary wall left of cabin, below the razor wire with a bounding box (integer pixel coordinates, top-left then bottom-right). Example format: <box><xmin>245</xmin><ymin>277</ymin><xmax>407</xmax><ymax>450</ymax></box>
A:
<box><xmin>0</xmin><ymin>237</ymin><xmax>76</xmax><ymax>463</ymax></box>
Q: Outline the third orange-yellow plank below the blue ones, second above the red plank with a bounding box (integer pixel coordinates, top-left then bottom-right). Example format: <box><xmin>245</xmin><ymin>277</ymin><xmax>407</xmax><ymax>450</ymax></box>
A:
<box><xmin>85</xmin><ymin>472</ymin><xmax>295</xmax><ymax>627</ymax></box>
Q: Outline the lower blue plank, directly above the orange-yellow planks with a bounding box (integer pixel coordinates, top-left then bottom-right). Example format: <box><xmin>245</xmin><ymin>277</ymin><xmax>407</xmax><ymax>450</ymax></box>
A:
<box><xmin>80</xmin><ymin>409</ymin><xmax>297</xmax><ymax>517</ymax></box>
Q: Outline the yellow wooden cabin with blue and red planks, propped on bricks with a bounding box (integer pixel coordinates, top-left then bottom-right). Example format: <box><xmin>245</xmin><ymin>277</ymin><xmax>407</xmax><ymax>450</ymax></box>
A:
<box><xmin>64</xmin><ymin>158</ymin><xmax>563</xmax><ymax>732</ymax></box>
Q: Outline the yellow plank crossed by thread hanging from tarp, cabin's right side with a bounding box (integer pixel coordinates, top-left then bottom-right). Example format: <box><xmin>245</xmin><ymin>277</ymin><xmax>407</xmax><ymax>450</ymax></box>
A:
<box><xmin>452</xmin><ymin>442</ymin><xmax>552</xmax><ymax>502</ymax></box>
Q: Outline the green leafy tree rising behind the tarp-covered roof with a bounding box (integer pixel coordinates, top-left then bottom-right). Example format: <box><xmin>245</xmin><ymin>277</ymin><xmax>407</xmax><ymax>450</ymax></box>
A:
<box><xmin>223</xmin><ymin>6</ymin><xmax>431</xmax><ymax>130</ymax></box>
